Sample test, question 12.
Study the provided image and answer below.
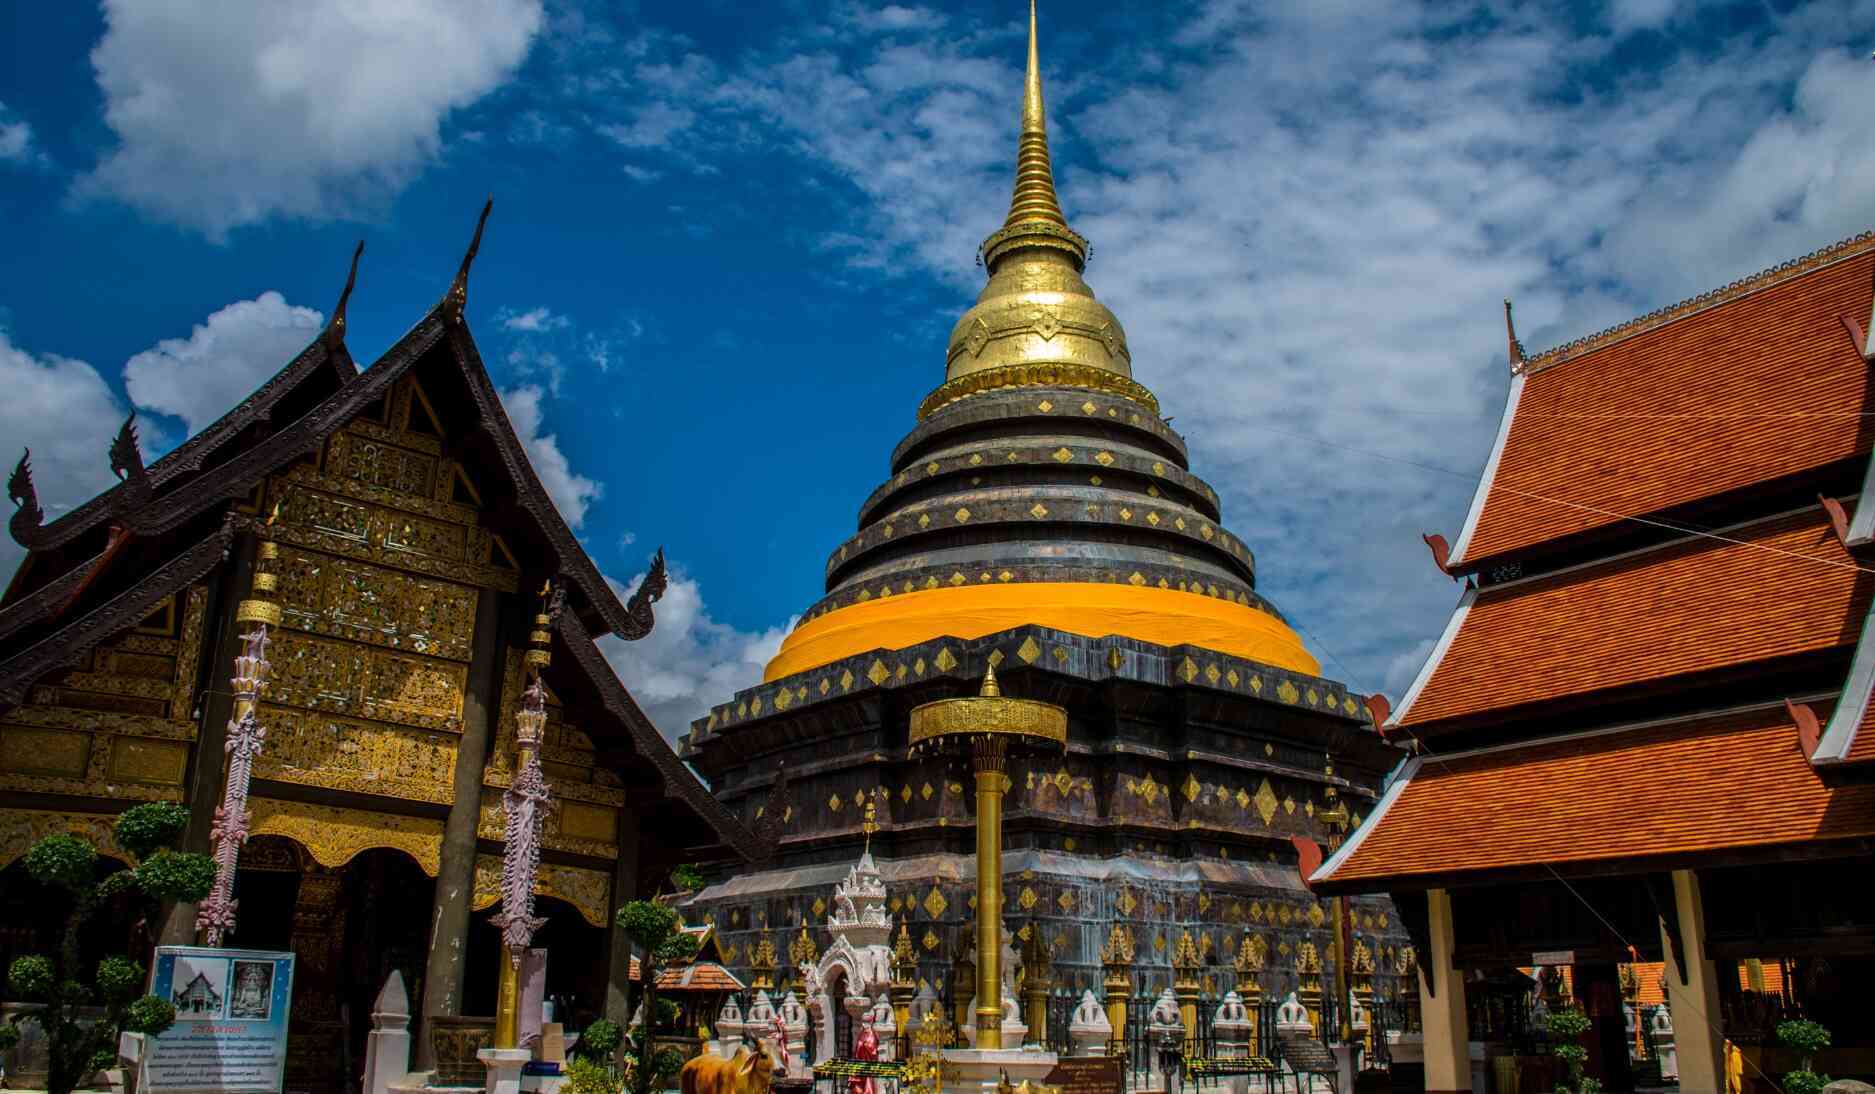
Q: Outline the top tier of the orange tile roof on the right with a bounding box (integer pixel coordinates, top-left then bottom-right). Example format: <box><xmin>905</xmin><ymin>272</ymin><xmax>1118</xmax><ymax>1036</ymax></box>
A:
<box><xmin>1455</xmin><ymin>235</ymin><xmax>1875</xmax><ymax>561</ymax></box>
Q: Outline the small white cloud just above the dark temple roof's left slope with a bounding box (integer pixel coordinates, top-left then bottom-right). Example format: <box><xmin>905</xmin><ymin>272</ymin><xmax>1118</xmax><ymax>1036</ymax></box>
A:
<box><xmin>124</xmin><ymin>291</ymin><xmax>324</xmax><ymax>442</ymax></box>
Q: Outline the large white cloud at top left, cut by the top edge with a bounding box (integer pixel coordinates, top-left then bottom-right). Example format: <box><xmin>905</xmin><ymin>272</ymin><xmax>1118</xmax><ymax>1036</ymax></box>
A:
<box><xmin>79</xmin><ymin>0</ymin><xmax>542</xmax><ymax>238</ymax></box>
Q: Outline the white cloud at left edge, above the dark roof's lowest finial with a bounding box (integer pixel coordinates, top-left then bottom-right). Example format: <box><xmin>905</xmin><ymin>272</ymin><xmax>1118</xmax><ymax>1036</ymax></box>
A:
<box><xmin>0</xmin><ymin>330</ymin><xmax>128</xmax><ymax>574</ymax></box>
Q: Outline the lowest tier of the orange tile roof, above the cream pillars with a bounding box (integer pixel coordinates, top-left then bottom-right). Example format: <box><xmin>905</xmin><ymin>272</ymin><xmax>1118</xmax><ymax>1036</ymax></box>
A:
<box><xmin>1314</xmin><ymin>706</ymin><xmax>1875</xmax><ymax>889</ymax></box>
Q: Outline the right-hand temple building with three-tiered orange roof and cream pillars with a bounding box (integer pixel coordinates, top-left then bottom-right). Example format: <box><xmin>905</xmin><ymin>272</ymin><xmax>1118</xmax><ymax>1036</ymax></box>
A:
<box><xmin>1314</xmin><ymin>235</ymin><xmax>1875</xmax><ymax>1090</ymax></box>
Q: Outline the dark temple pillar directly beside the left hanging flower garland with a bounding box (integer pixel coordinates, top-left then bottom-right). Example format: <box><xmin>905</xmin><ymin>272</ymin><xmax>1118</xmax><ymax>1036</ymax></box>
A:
<box><xmin>158</xmin><ymin>533</ymin><xmax>259</xmax><ymax>946</ymax></box>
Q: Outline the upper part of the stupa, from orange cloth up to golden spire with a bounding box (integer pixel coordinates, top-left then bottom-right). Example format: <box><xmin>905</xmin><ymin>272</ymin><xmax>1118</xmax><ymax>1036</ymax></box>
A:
<box><xmin>765</xmin><ymin>2</ymin><xmax>1320</xmax><ymax>681</ymax></box>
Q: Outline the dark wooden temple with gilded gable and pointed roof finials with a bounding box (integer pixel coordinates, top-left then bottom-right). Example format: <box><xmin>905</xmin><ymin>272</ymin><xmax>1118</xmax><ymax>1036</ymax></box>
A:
<box><xmin>0</xmin><ymin>210</ymin><xmax>758</xmax><ymax>1090</ymax></box>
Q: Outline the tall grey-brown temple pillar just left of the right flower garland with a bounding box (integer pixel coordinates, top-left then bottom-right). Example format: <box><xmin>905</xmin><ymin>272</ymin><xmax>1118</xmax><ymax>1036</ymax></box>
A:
<box><xmin>414</xmin><ymin>589</ymin><xmax>512</xmax><ymax>1071</ymax></box>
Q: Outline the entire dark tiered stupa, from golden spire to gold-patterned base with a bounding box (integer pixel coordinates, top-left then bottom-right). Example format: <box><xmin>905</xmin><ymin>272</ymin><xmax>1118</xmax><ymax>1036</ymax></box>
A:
<box><xmin>681</xmin><ymin>2</ymin><xmax>1412</xmax><ymax>1013</ymax></box>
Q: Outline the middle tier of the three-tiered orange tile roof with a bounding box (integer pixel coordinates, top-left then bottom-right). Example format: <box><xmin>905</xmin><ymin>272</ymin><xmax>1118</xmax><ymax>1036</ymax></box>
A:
<box><xmin>1397</xmin><ymin>509</ymin><xmax>1875</xmax><ymax>726</ymax></box>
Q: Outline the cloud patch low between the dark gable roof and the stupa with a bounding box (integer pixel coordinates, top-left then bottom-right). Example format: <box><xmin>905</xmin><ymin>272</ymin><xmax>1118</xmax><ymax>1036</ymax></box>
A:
<box><xmin>600</xmin><ymin>565</ymin><xmax>795</xmax><ymax>741</ymax></box>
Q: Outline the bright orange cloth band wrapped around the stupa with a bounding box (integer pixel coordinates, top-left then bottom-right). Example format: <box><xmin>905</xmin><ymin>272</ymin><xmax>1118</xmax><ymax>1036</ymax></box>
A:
<box><xmin>763</xmin><ymin>582</ymin><xmax>1322</xmax><ymax>681</ymax></box>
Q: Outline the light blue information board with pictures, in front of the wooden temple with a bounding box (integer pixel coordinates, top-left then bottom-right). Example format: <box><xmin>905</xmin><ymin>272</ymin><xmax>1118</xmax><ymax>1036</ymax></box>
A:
<box><xmin>143</xmin><ymin>946</ymin><xmax>293</xmax><ymax>1094</ymax></box>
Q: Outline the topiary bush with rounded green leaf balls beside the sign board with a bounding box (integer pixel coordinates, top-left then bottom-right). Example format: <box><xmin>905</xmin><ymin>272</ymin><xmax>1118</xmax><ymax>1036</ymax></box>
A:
<box><xmin>0</xmin><ymin>803</ymin><xmax>216</xmax><ymax>1094</ymax></box>
